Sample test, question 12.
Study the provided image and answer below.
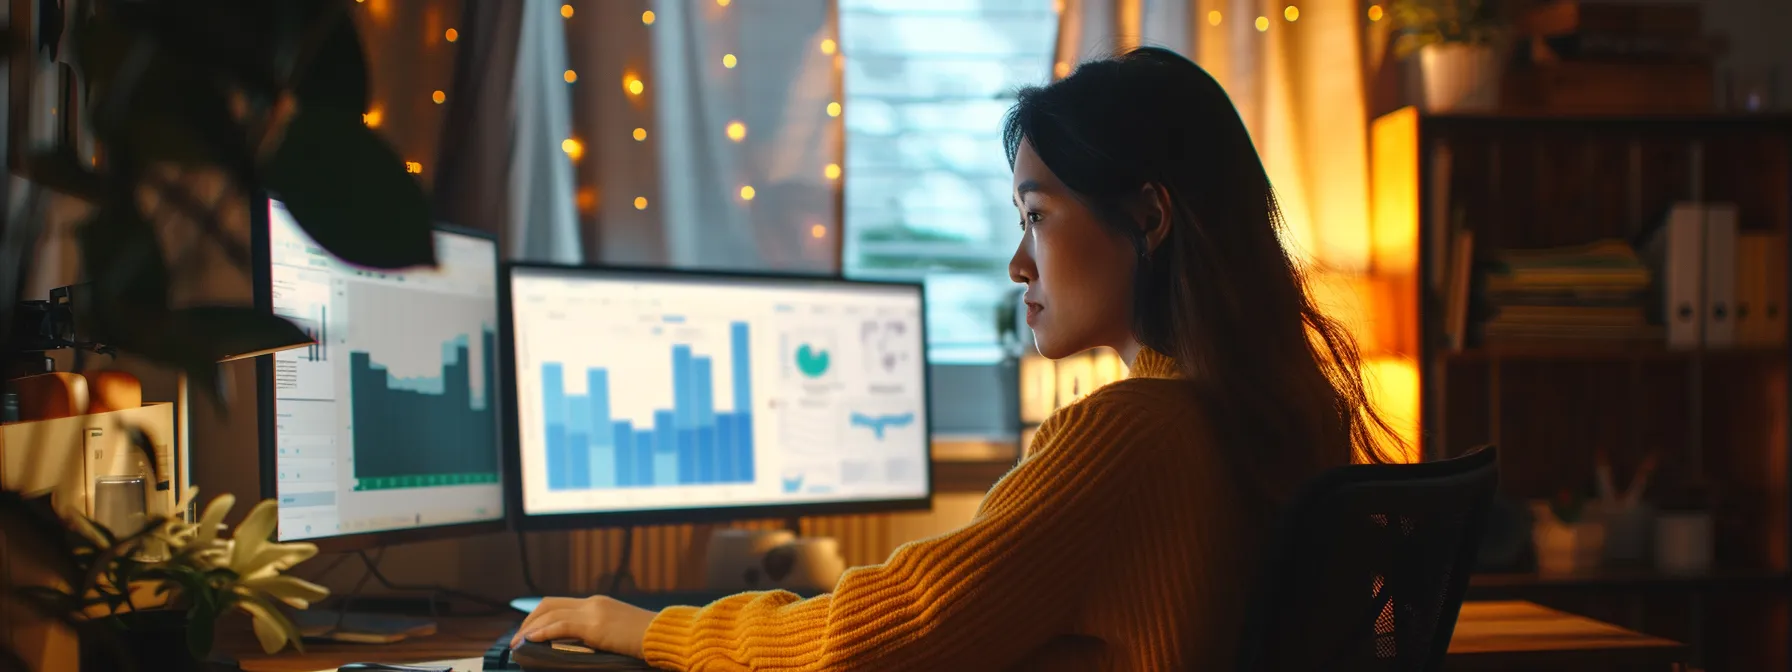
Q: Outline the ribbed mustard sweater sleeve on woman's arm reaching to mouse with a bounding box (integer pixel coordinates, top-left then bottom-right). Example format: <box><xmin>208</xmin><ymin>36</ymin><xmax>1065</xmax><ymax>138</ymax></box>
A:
<box><xmin>645</xmin><ymin>387</ymin><xmax>1167</xmax><ymax>670</ymax></box>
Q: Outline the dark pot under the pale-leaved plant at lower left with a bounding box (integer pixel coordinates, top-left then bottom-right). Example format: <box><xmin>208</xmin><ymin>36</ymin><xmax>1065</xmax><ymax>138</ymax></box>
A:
<box><xmin>81</xmin><ymin>609</ymin><xmax>204</xmax><ymax>672</ymax></box>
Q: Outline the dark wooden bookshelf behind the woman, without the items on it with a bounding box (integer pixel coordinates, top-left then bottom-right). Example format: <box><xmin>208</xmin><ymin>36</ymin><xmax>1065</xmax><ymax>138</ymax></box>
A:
<box><xmin>1371</xmin><ymin>108</ymin><xmax>1792</xmax><ymax>670</ymax></box>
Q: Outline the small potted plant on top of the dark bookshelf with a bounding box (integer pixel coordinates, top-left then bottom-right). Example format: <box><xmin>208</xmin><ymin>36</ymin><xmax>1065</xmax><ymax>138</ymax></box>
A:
<box><xmin>1389</xmin><ymin>0</ymin><xmax>1505</xmax><ymax>111</ymax></box>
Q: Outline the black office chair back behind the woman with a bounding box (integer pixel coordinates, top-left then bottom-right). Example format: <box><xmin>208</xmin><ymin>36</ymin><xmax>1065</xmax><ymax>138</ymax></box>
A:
<box><xmin>1238</xmin><ymin>446</ymin><xmax>1500</xmax><ymax>672</ymax></box>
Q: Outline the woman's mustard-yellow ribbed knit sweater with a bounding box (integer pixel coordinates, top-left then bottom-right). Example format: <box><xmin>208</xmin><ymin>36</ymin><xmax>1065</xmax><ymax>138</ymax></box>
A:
<box><xmin>645</xmin><ymin>351</ymin><xmax>1260</xmax><ymax>670</ymax></box>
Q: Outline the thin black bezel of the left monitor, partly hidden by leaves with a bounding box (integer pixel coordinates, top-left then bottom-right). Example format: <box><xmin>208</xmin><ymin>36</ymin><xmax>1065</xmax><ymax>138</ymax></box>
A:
<box><xmin>249</xmin><ymin>194</ymin><xmax>511</xmax><ymax>554</ymax></box>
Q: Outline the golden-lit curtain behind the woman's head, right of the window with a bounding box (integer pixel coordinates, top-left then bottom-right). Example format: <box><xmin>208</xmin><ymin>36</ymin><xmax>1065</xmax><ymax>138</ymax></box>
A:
<box><xmin>1057</xmin><ymin>0</ymin><xmax>1371</xmax><ymax>272</ymax></box>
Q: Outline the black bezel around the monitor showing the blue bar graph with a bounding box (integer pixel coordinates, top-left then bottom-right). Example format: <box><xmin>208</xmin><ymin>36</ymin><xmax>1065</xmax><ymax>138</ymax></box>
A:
<box><xmin>498</xmin><ymin>262</ymin><xmax>937</xmax><ymax>532</ymax></box>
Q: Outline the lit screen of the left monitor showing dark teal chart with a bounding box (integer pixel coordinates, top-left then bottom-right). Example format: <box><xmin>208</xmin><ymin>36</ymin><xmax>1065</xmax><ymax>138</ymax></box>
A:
<box><xmin>262</xmin><ymin>201</ymin><xmax>504</xmax><ymax>541</ymax></box>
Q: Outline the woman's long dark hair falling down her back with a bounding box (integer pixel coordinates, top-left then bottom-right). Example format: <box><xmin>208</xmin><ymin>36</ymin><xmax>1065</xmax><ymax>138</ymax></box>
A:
<box><xmin>1004</xmin><ymin>47</ymin><xmax>1394</xmax><ymax>496</ymax></box>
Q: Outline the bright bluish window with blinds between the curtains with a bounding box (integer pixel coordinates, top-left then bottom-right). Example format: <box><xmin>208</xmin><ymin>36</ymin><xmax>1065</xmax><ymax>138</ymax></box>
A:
<box><xmin>839</xmin><ymin>0</ymin><xmax>1057</xmax><ymax>364</ymax></box>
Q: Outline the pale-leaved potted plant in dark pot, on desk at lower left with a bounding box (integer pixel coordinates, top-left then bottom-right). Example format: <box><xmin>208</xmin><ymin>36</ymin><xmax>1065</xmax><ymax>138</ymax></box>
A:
<box><xmin>22</xmin><ymin>495</ymin><xmax>330</xmax><ymax>670</ymax></box>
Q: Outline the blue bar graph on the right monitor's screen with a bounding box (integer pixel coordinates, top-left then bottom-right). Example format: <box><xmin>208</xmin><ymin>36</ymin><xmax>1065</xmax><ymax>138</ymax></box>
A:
<box><xmin>541</xmin><ymin>323</ymin><xmax>754</xmax><ymax>489</ymax></box>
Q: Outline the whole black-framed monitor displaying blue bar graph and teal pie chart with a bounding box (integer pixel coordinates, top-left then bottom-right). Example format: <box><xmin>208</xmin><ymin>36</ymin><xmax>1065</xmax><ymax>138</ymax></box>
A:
<box><xmin>500</xmin><ymin>263</ymin><xmax>932</xmax><ymax>529</ymax></box>
